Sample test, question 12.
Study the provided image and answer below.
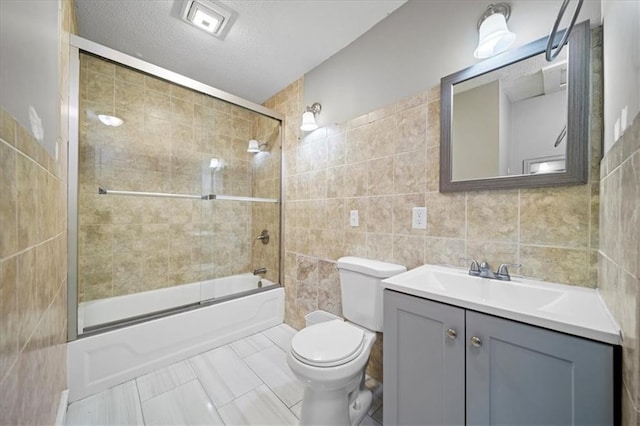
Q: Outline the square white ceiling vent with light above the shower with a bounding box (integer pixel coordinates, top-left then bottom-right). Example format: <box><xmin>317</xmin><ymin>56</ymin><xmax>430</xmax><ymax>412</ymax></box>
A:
<box><xmin>182</xmin><ymin>0</ymin><xmax>233</xmax><ymax>39</ymax></box>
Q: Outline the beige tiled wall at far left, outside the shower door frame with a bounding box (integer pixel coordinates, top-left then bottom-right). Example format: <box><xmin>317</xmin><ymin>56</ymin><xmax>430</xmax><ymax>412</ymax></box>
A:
<box><xmin>0</xmin><ymin>0</ymin><xmax>77</xmax><ymax>425</ymax></box>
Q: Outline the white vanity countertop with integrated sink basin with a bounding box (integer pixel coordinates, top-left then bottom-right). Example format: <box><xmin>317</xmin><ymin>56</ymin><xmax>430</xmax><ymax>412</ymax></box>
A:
<box><xmin>382</xmin><ymin>265</ymin><xmax>621</xmax><ymax>345</ymax></box>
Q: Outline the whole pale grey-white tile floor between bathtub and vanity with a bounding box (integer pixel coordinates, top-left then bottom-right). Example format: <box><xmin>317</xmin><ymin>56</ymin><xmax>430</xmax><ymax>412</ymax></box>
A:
<box><xmin>66</xmin><ymin>324</ymin><xmax>382</xmax><ymax>426</ymax></box>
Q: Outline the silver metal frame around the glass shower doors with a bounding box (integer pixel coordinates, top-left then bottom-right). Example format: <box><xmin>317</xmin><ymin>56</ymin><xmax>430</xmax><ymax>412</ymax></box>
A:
<box><xmin>67</xmin><ymin>34</ymin><xmax>286</xmax><ymax>342</ymax></box>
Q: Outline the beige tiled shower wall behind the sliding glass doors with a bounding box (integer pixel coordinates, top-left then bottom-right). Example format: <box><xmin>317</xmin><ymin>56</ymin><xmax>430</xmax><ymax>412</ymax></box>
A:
<box><xmin>78</xmin><ymin>54</ymin><xmax>278</xmax><ymax>301</ymax></box>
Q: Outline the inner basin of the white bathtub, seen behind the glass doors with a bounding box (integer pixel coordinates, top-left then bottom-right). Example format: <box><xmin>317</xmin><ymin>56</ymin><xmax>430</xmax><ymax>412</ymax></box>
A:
<box><xmin>78</xmin><ymin>272</ymin><xmax>274</xmax><ymax>334</ymax></box>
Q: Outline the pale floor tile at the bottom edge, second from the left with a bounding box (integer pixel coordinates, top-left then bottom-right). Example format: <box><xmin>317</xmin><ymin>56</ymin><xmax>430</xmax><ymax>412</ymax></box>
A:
<box><xmin>142</xmin><ymin>380</ymin><xmax>224</xmax><ymax>426</ymax></box>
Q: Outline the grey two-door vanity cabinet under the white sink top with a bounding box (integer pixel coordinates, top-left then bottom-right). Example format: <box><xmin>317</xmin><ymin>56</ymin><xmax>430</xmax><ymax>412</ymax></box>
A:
<box><xmin>384</xmin><ymin>290</ymin><xmax>614</xmax><ymax>426</ymax></box>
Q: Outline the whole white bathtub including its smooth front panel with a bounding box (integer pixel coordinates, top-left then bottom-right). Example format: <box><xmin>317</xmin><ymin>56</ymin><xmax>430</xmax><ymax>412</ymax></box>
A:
<box><xmin>67</xmin><ymin>284</ymin><xmax>284</xmax><ymax>402</ymax></box>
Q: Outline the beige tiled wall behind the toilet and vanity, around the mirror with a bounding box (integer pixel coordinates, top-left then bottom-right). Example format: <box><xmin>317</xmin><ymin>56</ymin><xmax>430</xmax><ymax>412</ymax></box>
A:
<box><xmin>266</xmin><ymin>29</ymin><xmax>602</xmax><ymax>379</ymax></box>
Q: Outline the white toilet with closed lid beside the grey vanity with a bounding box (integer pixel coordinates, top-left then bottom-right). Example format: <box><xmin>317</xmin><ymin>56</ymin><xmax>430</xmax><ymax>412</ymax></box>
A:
<box><xmin>287</xmin><ymin>257</ymin><xmax>407</xmax><ymax>426</ymax></box>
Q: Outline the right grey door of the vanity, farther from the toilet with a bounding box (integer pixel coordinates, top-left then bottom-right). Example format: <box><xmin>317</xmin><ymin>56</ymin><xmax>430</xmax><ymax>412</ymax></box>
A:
<box><xmin>464</xmin><ymin>311</ymin><xmax>614</xmax><ymax>425</ymax></box>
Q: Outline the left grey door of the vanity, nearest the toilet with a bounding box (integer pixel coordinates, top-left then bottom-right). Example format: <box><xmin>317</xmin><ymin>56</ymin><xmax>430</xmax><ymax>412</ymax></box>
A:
<box><xmin>383</xmin><ymin>290</ymin><xmax>465</xmax><ymax>426</ymax></box>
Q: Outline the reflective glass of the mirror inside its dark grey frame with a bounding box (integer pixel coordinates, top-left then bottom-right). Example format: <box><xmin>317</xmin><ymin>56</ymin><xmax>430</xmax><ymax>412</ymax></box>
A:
<box><xmin>451</xmin><ymin>49</ymin><xmax>567</xmax><ymax>181</ymax></box>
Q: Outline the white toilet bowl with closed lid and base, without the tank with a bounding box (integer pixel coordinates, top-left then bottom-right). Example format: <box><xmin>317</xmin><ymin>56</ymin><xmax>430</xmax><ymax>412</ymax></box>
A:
<box><xmin>287</xmin><ymin>320</ymin><xmax>376</xmax><ymax>426</ymax></box>
